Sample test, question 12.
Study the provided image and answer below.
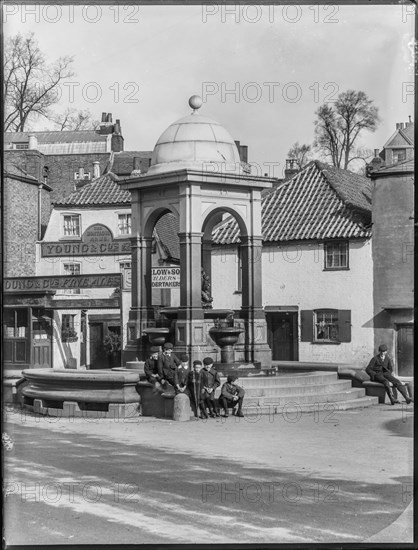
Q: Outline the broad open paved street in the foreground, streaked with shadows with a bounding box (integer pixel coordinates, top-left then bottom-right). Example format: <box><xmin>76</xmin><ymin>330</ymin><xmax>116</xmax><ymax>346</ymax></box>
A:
<box><xmin>4</xmin><ymin>405</ymin><xmax>413</xmax><ymax>544</ymax></box>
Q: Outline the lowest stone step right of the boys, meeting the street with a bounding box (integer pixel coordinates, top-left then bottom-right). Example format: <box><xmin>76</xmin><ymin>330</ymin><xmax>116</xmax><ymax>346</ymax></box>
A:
<box><xmin>238</xmin><ymin>396</ymin><xmax>379</xmax><ymax>416</ymax></box>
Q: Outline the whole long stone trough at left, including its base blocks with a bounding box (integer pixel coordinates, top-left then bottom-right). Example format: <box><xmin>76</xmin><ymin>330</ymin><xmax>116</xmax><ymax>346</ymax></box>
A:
<box><xmin>22</xmin><ymin>369</ymin><xmax>140</xmax><ymax>418</ymax></box>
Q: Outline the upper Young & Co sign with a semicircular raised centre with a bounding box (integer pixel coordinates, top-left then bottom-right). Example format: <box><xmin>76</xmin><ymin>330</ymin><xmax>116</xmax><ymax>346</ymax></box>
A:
<box><xmin>41</xmin><ymin>223</ymin><xmax>131</xmax><ymax>258</ymax></box>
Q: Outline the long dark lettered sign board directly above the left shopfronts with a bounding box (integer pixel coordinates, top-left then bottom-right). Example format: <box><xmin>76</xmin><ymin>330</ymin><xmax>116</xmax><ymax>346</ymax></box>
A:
<box><xmin>3</xmin><ymin>273</ymin><xmax>122</xmax><ymax>292</ymax></box>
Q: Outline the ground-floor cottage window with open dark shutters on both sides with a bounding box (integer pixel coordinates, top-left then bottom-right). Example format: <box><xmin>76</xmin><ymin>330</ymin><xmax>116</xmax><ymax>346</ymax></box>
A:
<box><xmin>300</xmin><ymin>308</ymin><xmax>351</xmax><ymax>344</ymax></box>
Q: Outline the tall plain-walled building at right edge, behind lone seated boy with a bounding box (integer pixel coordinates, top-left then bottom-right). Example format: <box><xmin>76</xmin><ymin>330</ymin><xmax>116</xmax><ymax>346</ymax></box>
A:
<box><xmin>368</xmin><ymin>120</ymin><xmax>415</xmax><ymax>376</ymax></box>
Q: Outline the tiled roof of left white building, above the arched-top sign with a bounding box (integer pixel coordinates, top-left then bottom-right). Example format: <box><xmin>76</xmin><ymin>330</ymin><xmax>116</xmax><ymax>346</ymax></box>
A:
<box><xmin>55</xmin><ymin>172</ymin><xmax>131</xmax><ymax>207</ymax></box>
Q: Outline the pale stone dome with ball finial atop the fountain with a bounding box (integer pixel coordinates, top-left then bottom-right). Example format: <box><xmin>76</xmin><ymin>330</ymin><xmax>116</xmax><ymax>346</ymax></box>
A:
<box><xmin>147</xmin><ymin>96</ymin><xmax>242</xmax><ymax>176</ymax></box>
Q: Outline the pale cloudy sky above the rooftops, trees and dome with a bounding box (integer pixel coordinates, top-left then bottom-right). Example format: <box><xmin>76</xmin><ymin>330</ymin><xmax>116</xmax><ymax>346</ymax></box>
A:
<box><xmin>4</xmin><ymin>4</ymin><xmax>414</xmax><ymax>177</ymax></box>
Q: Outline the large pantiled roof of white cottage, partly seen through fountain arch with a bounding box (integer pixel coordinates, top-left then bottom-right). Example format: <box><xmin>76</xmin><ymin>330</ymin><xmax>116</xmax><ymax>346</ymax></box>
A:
<box><xmin>213</xmin><ymin>161</ymin><xmax>371</xmax><ymax>244</ymax></box>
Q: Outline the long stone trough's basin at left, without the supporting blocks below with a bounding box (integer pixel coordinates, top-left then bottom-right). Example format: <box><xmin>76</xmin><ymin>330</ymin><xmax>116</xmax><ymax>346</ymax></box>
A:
<box><xmin>22</xmin><ymin>369</ymin><xmax>139</xmax><ymax>404</ymax></box>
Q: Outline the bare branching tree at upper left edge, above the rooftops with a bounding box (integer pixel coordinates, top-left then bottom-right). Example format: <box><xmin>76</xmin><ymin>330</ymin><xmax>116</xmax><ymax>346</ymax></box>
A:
<box><xmin>4</xmin><ymin>33</ymin><xmax>74</xmax><ymax>132</ymax></box>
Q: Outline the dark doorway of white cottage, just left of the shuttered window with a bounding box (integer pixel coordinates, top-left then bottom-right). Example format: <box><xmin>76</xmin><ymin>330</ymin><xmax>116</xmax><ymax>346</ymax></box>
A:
<box><xmin>267</xmin><ymin>311</ymin><xmax>299</xmax><ymax>361</ymax></box>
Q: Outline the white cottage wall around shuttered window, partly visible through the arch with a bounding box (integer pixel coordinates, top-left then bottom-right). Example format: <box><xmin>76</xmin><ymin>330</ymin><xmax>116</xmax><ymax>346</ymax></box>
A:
<box><xmin>212</xmin><ymin>240</ymin><xmax>374</xmax><ymax>366</ymax></box>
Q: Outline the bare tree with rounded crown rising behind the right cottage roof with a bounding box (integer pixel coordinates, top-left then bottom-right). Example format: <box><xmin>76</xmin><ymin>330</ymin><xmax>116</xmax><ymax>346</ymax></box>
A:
<box><xmin>314</xmin><ymin>90</ymin><xmax>380</xmax><ymax>169</ymax></box>
